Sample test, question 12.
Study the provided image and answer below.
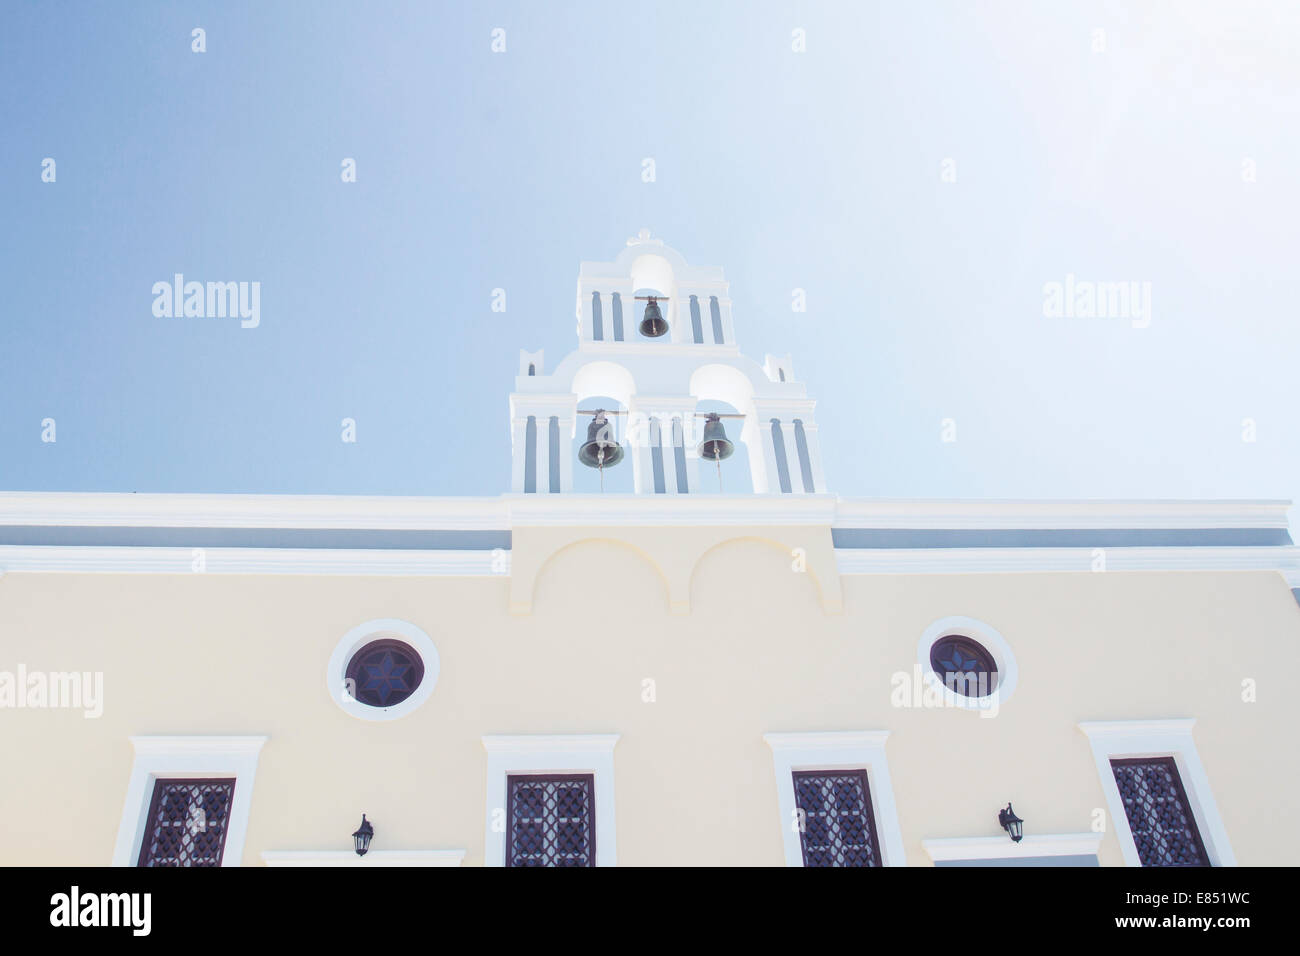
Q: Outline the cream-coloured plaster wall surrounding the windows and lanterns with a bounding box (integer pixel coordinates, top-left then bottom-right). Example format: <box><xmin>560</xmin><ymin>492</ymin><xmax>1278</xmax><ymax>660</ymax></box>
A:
<box><xmin>0</xmin><ymin>529</ymin><xmax>1300</xmax><ymax>865</ymax></box>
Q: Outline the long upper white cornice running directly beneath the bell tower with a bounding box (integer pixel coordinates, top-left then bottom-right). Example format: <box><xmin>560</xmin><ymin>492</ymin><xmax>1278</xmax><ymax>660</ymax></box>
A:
<box><xmin>0</xmin><ymin>492</ymin><xmax>1290</xmax><ymax>538</ymax></box>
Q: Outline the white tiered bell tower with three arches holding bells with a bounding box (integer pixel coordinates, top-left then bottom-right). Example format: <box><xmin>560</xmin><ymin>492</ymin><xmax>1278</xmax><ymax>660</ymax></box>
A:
<box><xmin>510</xmin><ymin>229</ymin><xmax>827</xmax><ymax>494</ymax></box>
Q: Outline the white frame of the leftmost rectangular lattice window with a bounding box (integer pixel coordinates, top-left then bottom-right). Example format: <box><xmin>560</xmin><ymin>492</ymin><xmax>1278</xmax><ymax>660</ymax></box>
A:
<box><xmin>113</xmin><ymin>736</ymin><xmax>268</xmax><ymax>866</ymax></box>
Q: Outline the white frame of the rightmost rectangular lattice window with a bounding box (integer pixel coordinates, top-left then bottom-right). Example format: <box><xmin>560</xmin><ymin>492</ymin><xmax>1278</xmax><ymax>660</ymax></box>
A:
<box><xmin>1079</xmin><ymin>718</ymin><xmax>1236</xmax><ymax>866</ymax></box>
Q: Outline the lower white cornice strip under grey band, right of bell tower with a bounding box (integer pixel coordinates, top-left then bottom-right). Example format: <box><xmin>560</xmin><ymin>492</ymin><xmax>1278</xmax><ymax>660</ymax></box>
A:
<box><xmin>835</xmin><ymin>545</ymin><xmax>1300</xmax><ymax>575</ymax></box>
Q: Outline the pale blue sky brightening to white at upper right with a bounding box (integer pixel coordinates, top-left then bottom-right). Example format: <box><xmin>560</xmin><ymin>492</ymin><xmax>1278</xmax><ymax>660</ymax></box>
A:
<box><xmin>0</xmin><ymin>3</ymin><xmax>1300</xmax><ymax>528</ymax></box>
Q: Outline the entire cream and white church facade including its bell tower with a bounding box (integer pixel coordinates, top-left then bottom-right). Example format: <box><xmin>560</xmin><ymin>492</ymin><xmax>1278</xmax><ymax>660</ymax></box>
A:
<box><xmin>0</xmin><ymin>232</ymin><xmax>1300</xmax><ymax>866</ymax></box>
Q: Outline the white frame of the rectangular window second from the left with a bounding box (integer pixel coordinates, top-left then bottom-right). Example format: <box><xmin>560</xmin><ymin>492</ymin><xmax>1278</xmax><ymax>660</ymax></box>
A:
<box><xmin>482</xmin><ymin>734</ymin><xmax>619</xmax><ymax>866</ymax></box>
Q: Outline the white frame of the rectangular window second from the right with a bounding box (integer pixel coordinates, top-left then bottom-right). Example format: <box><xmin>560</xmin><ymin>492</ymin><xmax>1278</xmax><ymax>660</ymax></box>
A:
<box><xmin>763</xmin><ymin>730</ymin><xmax>907</xmax><ymax>866</ymax></box>
